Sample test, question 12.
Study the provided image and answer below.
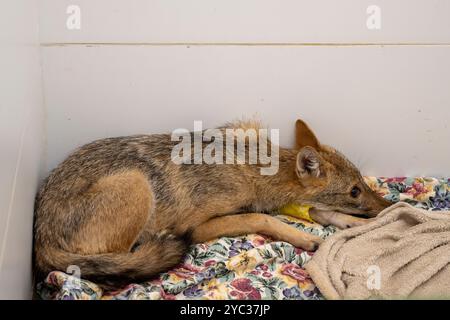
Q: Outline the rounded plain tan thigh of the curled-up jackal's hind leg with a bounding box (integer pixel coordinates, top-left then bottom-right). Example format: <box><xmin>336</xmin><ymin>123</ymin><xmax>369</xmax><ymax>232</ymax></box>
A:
<box><xmin>70</xmin><ymin>170</ymin><xmax>152</xmax><ymax>254</ymax></box>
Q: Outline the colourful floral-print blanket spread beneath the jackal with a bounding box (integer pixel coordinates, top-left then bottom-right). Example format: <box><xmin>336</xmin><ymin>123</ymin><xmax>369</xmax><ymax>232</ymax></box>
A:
<box><xmin>37</xmin><ymin>177</ymin><xmax>450</xmax><ymax>300</ymax></box>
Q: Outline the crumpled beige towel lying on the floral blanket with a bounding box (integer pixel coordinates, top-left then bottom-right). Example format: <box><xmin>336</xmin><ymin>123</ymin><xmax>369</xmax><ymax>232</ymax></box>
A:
<box><xmin>306</xmin><ymin>202</ymin><xmax>450</xmax><ymax>299</ymax></box>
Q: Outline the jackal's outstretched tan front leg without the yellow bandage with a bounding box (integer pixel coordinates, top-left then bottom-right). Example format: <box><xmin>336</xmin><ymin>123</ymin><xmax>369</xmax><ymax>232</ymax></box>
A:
<box><xmin>192</xmin><ymin>213</ymin><xmax>322</xmax><ymax>250</ymax></box>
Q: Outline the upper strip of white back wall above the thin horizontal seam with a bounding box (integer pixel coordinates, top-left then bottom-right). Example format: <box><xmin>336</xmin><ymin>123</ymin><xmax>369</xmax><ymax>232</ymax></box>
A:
<box><xmin>40</xmin><ymin>0</ymin><xmax>450</xmax><ymax>43</ymax></box>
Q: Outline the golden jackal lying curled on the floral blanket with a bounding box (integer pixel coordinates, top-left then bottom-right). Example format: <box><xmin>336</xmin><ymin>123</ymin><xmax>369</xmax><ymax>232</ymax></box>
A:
<box><xmin>34</xmin><ymin>120</ymin><xmax>389</xmax><ymax>287</ymax></box>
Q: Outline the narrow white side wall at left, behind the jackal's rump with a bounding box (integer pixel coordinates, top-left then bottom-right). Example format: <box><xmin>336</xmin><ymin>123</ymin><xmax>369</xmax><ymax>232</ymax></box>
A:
<box><xmin>0</xmin><ymin>0</ymin><xmax>44</xmax><ymax>299</ymax></box>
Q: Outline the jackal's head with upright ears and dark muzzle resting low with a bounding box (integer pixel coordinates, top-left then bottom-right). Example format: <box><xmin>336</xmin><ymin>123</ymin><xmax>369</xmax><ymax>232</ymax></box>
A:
<box><xmin>296</xmin><ymin>120</ymin><xmax>390</xmax><ymax>217</ymax></box>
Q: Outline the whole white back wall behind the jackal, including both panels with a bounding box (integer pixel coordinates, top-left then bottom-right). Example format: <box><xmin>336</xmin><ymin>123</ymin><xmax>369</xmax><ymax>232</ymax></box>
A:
<box><xmin>41</xmin><ymin>0</ymin><xmax>450</xmax><ymax>176</ymax></box>
